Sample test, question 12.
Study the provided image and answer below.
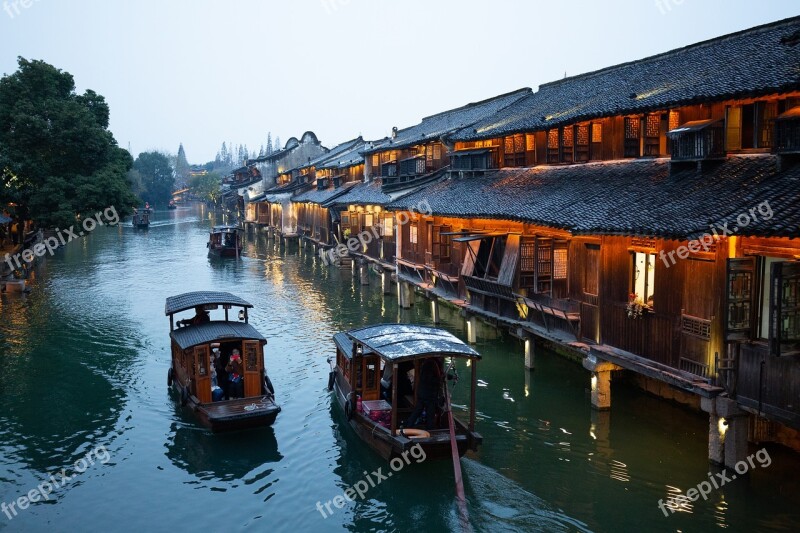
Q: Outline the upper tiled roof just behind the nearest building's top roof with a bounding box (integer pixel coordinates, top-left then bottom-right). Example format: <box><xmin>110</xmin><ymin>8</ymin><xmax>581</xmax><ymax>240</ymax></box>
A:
<box><xmin>364</xmin><ymin>88</ymin><xmax>531</xmax><ymax>154</ymax></box>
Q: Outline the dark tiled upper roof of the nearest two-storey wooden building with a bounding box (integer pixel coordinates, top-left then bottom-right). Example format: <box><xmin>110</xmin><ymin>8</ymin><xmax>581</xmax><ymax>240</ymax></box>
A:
<box><xmin>448</xmin><ymin>17</ymin><xmax>800</xmax><ymax>141</ymax></box>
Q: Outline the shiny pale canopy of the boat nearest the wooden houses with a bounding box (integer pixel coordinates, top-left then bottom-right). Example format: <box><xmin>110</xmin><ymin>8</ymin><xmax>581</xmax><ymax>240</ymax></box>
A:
<box><xmin>334</xmin><ymin>324</ymin><xmax>481</xmax><ymax>362</ymax></box>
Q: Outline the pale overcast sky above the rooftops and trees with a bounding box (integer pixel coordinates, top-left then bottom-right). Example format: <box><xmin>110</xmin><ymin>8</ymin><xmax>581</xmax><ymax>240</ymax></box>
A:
<box><xmin>0</xmin><ymin>0</ymin><xmax>800</xmax><ymax>163</ymax></box>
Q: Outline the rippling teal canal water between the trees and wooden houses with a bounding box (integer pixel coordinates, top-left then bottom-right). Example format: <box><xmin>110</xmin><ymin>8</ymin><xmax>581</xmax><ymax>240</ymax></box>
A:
<box><xmin>0</xmin><ymin>202</ymin><xmax>800</xmax><ymax>532</ymax></box>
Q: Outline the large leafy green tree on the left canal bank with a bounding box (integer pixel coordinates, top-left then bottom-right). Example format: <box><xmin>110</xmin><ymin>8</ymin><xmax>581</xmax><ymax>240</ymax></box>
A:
<box><xmin>0</xmin><ymin>57</ymin><xmax>136</xmax><ymax>227</ymax></box>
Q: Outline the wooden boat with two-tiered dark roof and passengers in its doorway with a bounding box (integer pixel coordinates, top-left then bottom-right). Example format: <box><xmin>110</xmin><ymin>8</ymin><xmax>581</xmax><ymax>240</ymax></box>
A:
<box><xmin>165</xmin><ymin>291</ymin><xmax>281</xmax><ymax>432</ymax></box>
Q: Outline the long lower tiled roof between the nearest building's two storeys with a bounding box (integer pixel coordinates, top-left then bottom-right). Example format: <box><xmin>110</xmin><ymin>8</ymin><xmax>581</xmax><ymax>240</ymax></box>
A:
<box><xmin>387</xmin><ymin>155</ymin><xmax>800</xmax><ymax>239</ymax></box>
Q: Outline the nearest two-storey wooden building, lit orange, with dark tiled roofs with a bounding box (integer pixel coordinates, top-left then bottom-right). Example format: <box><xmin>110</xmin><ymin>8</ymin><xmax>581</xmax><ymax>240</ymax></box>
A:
<box><xmin>384</xmin><ymin>18</ymin><xmax>800</xmax><ymax>465</ymax></box>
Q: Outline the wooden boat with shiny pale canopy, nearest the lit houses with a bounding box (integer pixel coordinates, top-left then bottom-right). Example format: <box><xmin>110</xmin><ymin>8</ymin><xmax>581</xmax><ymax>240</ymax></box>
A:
<box><xmin>328</xmin><ymin>324</ymin><xmax>483</xmax><ymax>459</ymax></box>
